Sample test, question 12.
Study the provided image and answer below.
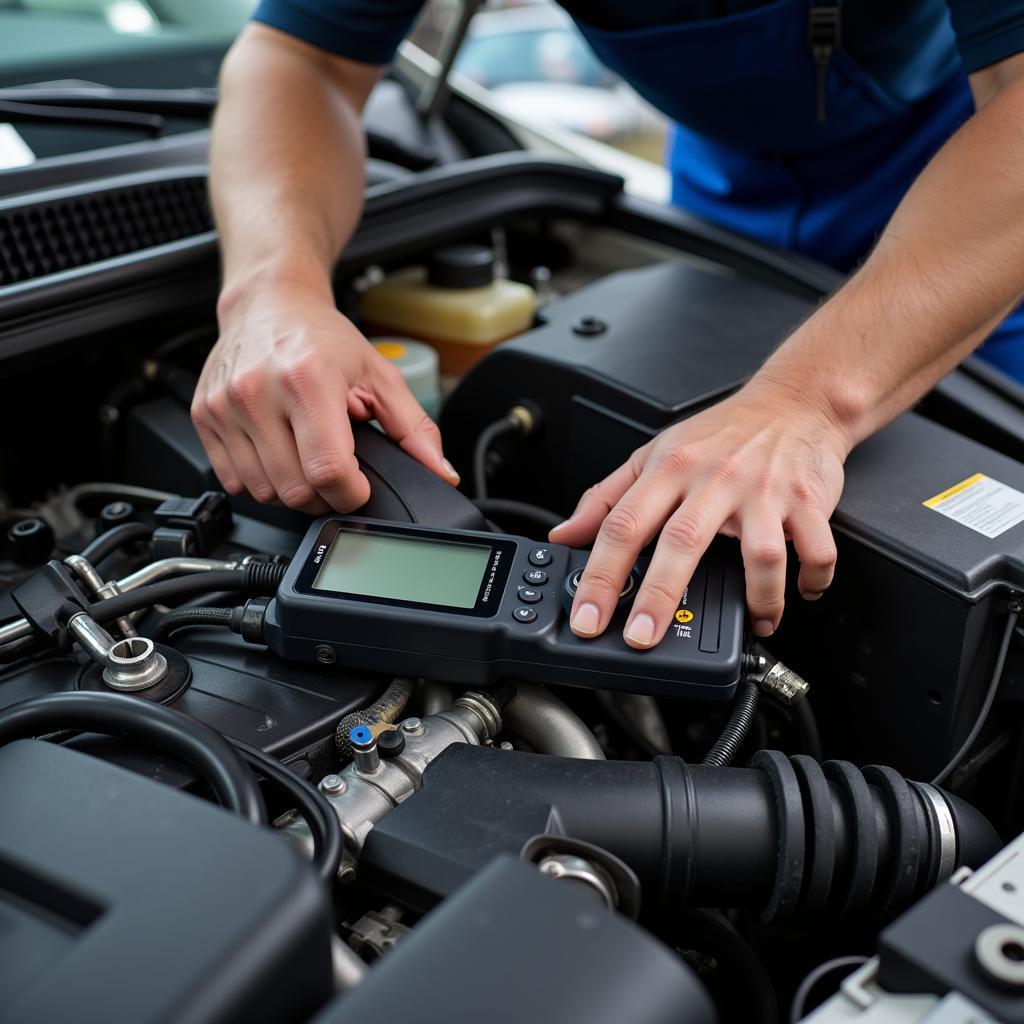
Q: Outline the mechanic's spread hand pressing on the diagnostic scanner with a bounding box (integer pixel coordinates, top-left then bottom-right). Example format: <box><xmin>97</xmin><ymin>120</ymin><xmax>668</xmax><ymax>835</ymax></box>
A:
<box><xmin>551</xmin><ymin>379</ymin><xmax>849</xmax><ymax>648</ymax></box>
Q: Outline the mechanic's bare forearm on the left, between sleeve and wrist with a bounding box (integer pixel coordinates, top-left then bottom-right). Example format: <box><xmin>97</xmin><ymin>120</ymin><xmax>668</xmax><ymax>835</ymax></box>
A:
<box><xmin>210</xmin><ymin>26</ymin><xmax>372</xmax><ymax>313</ymax></box>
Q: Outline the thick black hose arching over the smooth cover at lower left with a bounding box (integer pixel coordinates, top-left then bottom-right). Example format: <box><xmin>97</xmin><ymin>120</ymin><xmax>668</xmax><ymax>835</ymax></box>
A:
<box><xmin>0</xmin><ymin>690</ymin><xmax>266</xmax><ymax>825</ymax></box>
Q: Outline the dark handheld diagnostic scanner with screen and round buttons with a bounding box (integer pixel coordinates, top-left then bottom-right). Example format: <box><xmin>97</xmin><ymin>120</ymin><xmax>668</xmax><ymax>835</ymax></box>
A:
<box><xmin>265</xmin><ymin>516</ymin><xmax>744</xmax><ymax>700</ymax></box>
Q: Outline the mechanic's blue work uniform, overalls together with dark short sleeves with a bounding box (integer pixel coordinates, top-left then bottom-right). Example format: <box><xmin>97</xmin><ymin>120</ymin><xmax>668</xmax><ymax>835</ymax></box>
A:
<box><xmin>254</xmin><ymin>0</ymin><xmax>1024</xmax><ymax>380</ymax></box>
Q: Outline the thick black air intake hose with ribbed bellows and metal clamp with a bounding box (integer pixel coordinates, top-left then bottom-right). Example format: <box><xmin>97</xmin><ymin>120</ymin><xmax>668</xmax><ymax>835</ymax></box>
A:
<box><xmin>372</xmin><ymin>745</ymin><xmax>1001</xmax><ymax>922</ymax></box>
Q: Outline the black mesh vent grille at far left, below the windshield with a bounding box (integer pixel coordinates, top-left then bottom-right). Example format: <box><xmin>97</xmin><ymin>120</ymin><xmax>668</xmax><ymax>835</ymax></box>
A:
<box><xmin>0</xmin><ymin>176</ymin><xmax>213</xmax><ymax>287</ymax></box>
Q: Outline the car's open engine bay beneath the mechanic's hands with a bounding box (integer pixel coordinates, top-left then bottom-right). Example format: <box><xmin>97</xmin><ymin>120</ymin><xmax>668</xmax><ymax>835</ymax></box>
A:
<box><xmin>0</xmin><ymin>121</ymin><xmax>1024</xmax><ymax>1024</ymax></box>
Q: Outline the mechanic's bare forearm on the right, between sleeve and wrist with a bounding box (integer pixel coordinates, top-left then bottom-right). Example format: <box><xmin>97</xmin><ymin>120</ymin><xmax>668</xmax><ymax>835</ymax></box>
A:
<box><xmin>752</xmin><ymin>74</ymin><xmax>1024</xmax><ymax>446</ymax></box>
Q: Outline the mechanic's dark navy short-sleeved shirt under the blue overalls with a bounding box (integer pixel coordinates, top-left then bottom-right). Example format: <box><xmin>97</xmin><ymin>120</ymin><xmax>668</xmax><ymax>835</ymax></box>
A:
<box><xmin>253</xmin><ymin>0</ymin><xmax>1024</xmax><ymax>98</ymax></box>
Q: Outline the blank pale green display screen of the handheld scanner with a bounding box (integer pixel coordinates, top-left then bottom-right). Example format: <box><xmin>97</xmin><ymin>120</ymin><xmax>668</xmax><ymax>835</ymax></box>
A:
<box><xmin>313</xmin><ymin>529</ymin><xmax>490</xmax><ymax>608</ymax></box>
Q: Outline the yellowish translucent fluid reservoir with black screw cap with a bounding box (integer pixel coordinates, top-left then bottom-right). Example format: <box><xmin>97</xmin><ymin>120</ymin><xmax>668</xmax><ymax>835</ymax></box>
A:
<box><xmin>362</xmin><ymin>246</ymin><xmax>536</xmax><ymax>377</ymax></box>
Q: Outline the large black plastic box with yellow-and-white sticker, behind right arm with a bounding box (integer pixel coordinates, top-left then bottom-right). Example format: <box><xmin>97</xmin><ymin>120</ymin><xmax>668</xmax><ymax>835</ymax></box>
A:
<box><xmin>442</xmin><ymin>263</ymin><xmax>1024</xmax><ymax>778</ymax></box>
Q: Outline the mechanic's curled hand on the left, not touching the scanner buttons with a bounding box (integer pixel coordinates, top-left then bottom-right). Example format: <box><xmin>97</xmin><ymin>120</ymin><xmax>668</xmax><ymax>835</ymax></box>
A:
<box><xmin>191</xmin><ymin>291</ymin><xmax>459</xmax><ymax>515</ymax></box>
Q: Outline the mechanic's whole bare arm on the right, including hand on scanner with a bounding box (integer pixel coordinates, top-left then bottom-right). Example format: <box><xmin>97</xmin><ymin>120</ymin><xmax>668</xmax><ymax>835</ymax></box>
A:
<box><xmin>551</xmin><ymin>56</ymin><xmax>1024</xmax><ymax>648</ymax></box>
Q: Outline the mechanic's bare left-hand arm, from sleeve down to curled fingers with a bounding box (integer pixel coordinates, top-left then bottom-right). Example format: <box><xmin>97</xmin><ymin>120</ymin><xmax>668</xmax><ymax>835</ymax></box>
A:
<box><xmin>193</xmin><ymin>25</ymin><xmax>458</xmax><ymax>513</ymax></box>
